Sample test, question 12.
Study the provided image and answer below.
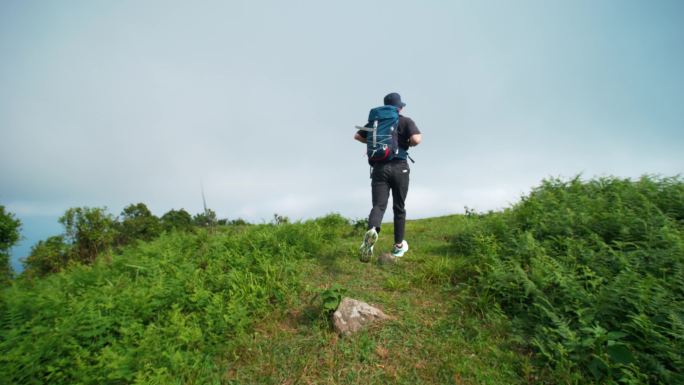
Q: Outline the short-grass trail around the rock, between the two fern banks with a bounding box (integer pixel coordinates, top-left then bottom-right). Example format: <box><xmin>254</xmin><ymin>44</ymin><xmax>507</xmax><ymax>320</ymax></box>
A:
<box><xmin>225</xmin><ymin>217</ymin><xmax>529</xmax><ymax>385</ymax></box>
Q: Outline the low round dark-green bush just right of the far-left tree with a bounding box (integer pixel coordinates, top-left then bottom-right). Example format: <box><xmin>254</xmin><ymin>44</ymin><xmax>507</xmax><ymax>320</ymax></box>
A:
<box><xmin>24</xmin><ymin>235</ymin><xmax>70</xmax><ymax>276</ymax></box>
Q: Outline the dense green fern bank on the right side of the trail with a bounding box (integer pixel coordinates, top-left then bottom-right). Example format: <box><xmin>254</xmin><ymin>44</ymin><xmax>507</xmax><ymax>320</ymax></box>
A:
<box><xmin>453</xmin><ymin>177</ymin><xmax>684</xmax><ymax>384</ymax></box>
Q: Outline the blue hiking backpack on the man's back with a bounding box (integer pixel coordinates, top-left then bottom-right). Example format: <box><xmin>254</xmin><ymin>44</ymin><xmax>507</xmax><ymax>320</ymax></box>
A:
<box><xmin>357</xmin><ymin>106</ymin><xmax>399</xmax><ymax>165</ymax></box>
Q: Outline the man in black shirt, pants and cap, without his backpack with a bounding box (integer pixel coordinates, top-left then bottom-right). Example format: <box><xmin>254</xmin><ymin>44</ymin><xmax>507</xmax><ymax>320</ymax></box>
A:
<box><xmin>354</xmin><ymin>92</ymin><xmax>422</xmax><ymax>262</ymax></box>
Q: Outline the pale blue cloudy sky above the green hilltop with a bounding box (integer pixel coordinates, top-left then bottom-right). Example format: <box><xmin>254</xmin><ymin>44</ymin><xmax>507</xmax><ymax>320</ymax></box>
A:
<box><xmin>0</xmin><ymin>0</ymin><xmax>684</xmax><ymax>269</ymax></box>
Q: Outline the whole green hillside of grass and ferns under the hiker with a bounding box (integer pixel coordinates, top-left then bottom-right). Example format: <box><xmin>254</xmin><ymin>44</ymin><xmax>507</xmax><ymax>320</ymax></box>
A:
<box><xmin>0</xmin><ymin>178</ymin><xmax>684</xmax><ymax>385</ymax></box>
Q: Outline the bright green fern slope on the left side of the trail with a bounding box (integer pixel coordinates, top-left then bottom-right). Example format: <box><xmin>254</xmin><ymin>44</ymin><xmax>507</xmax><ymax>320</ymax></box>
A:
<box><xmin>0</xmin><ymin>221</ymin><xmax>325</xmax><ymax>384</ymax></box>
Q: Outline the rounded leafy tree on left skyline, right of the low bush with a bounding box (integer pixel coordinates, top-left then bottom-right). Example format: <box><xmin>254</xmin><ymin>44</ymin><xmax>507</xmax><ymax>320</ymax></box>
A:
<box><xmin>59</xmin><ymin>207</ymin><xmax>117</xmax><ymax>263</ymax></box>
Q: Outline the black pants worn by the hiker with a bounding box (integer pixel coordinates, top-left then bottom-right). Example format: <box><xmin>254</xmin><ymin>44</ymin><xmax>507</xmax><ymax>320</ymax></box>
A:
<box><xmin>368</xmin><ymin>160</ymin><xmax>411</xmax><ymax>244</ymax></box>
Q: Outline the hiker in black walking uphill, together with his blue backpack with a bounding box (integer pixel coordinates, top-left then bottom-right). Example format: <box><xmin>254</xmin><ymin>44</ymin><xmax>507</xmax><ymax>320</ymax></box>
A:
<box><xmin>354</xmin><ymin>92</ymin><xmax>422</xmax><ymax>262</ymax></box>
